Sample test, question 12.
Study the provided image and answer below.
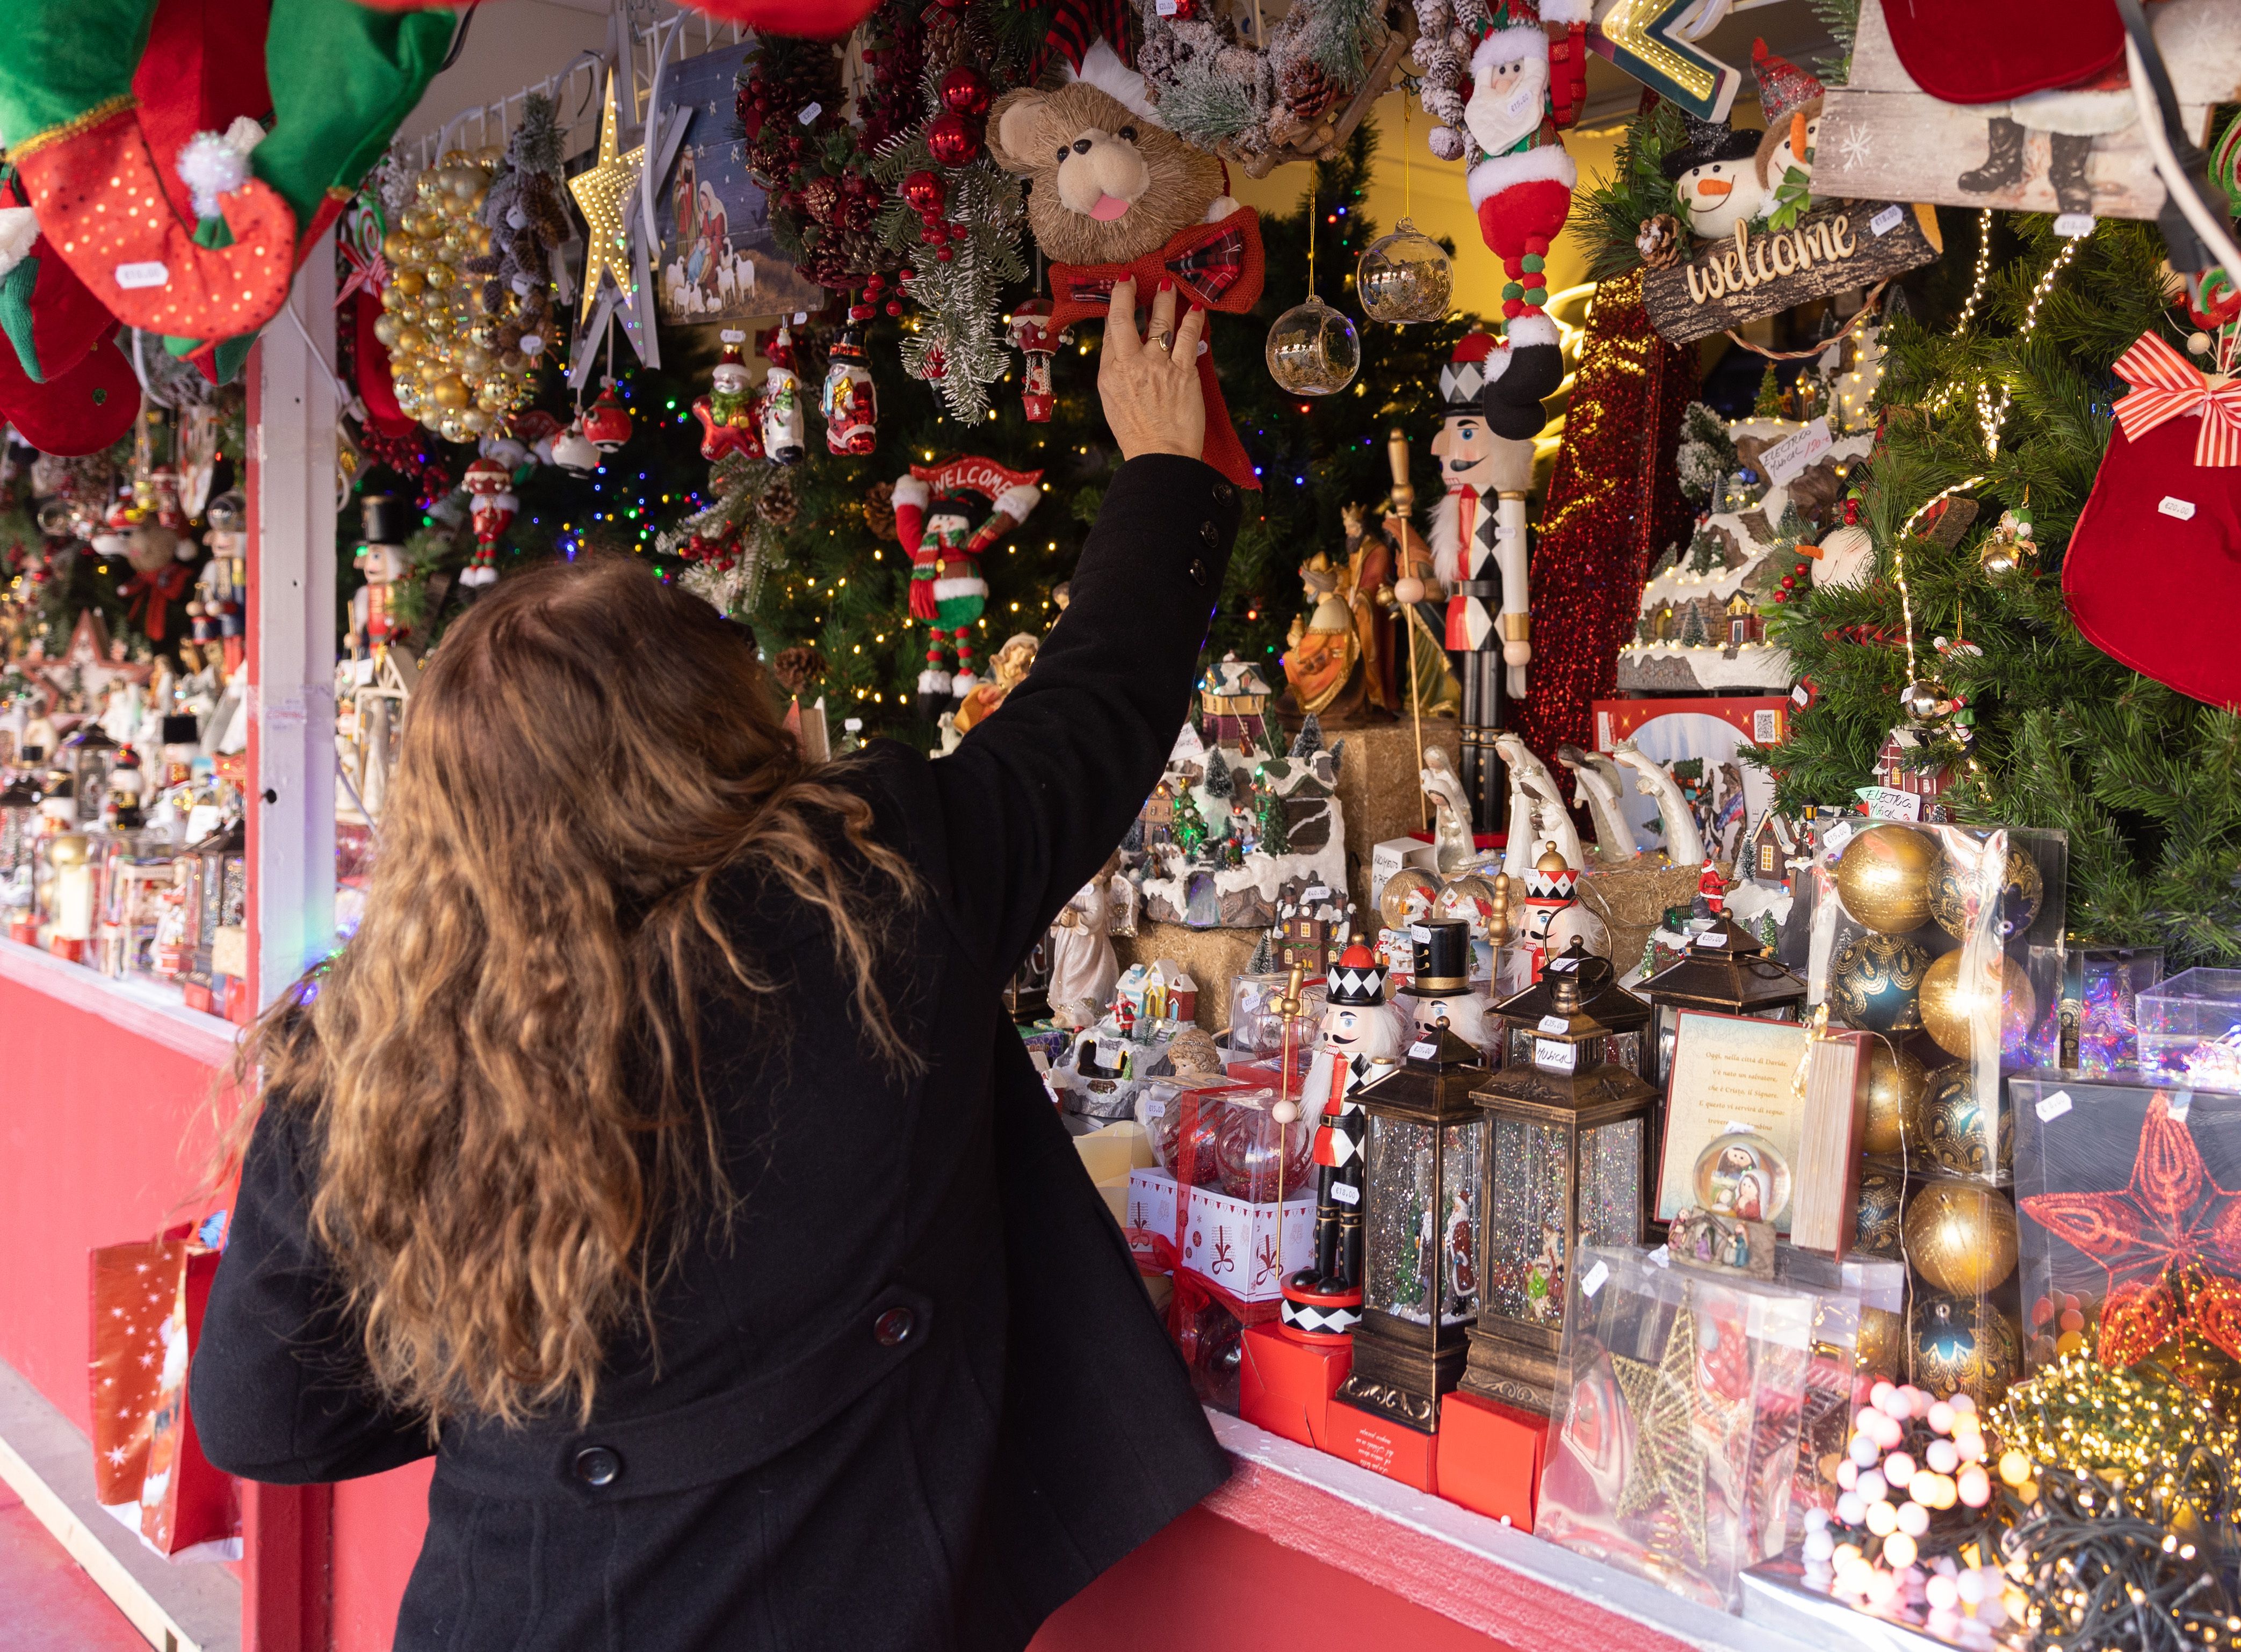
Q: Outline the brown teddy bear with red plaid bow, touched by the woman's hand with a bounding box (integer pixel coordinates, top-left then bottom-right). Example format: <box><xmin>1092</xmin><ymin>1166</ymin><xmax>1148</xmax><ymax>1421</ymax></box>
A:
<box><xmin>988</xmin><ymin>81</ymin><xmax>1262</xmax><ymax>489</ymax></box>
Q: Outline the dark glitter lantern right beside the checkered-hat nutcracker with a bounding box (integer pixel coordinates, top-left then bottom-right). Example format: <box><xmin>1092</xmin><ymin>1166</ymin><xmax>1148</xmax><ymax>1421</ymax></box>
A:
<box><xmin>1338</xmin><ymin>1027</ymin><xmax>1488</xmax><ymax>1434</ymax></box>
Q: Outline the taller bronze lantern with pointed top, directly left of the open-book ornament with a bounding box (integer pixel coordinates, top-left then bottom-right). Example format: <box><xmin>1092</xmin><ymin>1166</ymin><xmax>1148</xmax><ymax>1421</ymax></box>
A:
<box><xmin>1463</xmin><ymin>959</ymin><xmax>1658</xmax><ymax>1415</ymax></box>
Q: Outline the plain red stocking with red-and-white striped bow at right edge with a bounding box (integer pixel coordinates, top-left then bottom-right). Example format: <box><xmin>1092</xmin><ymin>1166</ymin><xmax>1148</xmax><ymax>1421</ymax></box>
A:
<box><xmin>2062</xmin><ymin>334</ymin><xmax>2241</xmax><ymax>708</ymax></box>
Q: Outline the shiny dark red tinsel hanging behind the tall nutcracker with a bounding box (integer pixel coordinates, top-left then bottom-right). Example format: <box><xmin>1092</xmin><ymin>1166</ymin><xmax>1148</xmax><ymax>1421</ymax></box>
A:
<box><xmin>1508</xmin><ymin>271</ymin><xmax>1696</xmax><ymax>787</ymax></box>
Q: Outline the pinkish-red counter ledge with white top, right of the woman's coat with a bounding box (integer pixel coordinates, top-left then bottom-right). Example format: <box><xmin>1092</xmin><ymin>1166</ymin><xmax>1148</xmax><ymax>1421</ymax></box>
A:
<box><xmin>1206</xmin><ymin>1410</ymin><xmax>1809</xmax><ymax>1652</ymax></box>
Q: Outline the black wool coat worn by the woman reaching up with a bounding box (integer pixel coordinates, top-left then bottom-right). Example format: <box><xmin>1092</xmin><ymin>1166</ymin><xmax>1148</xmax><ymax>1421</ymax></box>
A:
<box><xmin>191</xmin><ymin>455</ymin><xmax>1239</xmax><ymax>1652</ymax></box>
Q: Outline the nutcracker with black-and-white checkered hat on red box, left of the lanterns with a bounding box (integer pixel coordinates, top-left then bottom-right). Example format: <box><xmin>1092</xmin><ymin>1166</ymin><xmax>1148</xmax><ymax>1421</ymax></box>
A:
<box><xmin>1277</xmin><ymin>941</ymin><xmax>1401</xmax><ymax>1343</ymax></box>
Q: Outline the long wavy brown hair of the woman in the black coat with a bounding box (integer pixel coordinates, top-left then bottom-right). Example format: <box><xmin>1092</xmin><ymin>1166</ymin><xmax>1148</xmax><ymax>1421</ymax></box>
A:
<box><xmin>233</xmin><ymin>558</ymin><xmax>916</xmax><ymax>1425</ymax></box>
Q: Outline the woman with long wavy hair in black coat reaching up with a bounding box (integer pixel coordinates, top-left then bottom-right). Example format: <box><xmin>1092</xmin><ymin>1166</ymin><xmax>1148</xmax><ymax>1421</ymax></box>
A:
<box><xmin>191</xmin><ymin>277</ymin><xmax>1239</xmax><ymax>1652</ymax></box>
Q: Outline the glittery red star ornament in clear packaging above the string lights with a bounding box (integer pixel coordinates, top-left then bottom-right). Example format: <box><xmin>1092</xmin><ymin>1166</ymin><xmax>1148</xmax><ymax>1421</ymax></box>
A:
<box><xmin>2021</xmin><ymin>1094</ymin><xmax>2241</xmax><ymax>1365</ymax></box>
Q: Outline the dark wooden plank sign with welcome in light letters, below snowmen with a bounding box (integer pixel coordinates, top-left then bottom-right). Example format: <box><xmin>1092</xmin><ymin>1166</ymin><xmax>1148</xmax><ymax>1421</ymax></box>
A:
<box><xmin>1643</xmin><ymin>202</ymin><xmax>1945</xmax><ymax>345</ymax></box>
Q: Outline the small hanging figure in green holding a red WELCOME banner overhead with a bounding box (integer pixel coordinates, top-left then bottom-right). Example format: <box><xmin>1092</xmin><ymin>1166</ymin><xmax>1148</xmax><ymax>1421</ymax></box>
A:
<box><xmin>894</xmin><ymin>457</ymin><xmax>1042</xmax><ymax>718</ymax></box>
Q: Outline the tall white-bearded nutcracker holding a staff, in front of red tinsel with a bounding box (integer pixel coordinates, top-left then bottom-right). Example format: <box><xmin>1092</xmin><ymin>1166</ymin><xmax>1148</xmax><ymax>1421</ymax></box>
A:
<box><xmin>1385</xmin><ymin>332</ymin><xmax>1533</xmax><ymax>831</ymax></box>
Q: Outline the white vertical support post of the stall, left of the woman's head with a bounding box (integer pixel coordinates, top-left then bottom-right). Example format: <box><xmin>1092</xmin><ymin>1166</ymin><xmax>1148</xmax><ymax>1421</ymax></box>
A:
<box><xmin>249</xmin><ymin>231</ymin><xmax>338</xmax><ymax>1006</ymax></box>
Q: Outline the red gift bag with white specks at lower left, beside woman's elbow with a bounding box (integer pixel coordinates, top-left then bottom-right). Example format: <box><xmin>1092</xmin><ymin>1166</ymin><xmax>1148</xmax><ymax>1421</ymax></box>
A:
<box><xmin>90</xmin><ymin>1219</ymin><xmax>242</xmax><ymax>1558</ymax></box>
